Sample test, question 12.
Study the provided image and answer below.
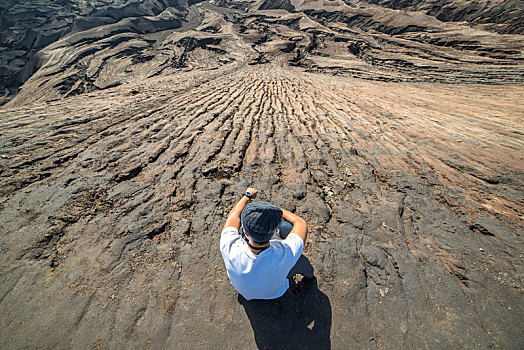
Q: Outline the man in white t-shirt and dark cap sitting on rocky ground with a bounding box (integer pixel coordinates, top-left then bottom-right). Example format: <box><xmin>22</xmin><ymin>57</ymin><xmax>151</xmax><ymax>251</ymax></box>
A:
<box><xmin>220</xmin><ymin>188</ymin><xmax>314</xmax><ymax>300</ymax></box>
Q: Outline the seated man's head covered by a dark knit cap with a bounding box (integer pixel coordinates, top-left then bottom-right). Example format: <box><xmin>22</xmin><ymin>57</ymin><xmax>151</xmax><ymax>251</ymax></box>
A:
<box><xmin>240</xmin><ymin>201</ymin><xmax>282</xmax><ymax>243</ymax></box>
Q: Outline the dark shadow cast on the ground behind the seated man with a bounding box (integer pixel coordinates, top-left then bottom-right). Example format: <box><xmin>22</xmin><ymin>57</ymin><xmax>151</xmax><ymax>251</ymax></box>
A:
<box><xmin>238</xmin><ymin>278</ymin><xmax>331</xmax><ymax>349</ymax></box>
